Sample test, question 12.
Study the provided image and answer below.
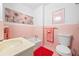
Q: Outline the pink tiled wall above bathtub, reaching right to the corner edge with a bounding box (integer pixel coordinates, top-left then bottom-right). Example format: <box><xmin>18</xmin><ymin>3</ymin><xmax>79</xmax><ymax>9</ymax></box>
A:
<box><xmin>7</xmin><ymin>23</ymin><xmax>42</xmax><ymax>39</ymax></box>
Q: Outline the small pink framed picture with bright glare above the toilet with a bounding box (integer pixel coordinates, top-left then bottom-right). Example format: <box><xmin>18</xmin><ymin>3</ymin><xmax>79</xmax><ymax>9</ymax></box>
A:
<box><xmin>52</xmin><ymin>8</ymin><xmax>65</xmax><ymax>24</ymax></box>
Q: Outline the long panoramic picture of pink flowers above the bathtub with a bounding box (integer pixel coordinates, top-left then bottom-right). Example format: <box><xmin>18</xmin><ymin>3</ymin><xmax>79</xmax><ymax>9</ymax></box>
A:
<box><xmin>5</xmin><ymin>8</ymin><xmax>33</xmax><ymax>25</ymax></box>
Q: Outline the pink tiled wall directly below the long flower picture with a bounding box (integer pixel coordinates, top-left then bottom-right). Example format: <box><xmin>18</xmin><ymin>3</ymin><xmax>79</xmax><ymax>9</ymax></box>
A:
<box><xmin>6</xmin><ymin>24</ymin><xmax>34</xmax><ymax>37</ymax></box>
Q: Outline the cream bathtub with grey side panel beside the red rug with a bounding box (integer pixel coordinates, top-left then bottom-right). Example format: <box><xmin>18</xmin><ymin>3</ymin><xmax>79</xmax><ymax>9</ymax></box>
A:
<box><xmin>0</xmin><ymin>37</ymin><xmax>35</xmax><ymax>56</ymax></box>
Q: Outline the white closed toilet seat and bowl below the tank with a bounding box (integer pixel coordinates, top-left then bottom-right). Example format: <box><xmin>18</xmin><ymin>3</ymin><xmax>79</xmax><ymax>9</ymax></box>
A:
<box><xmin>56</xmin><ymin>45</ymin><xmax>71</xmax><ymax>56</ymax></box>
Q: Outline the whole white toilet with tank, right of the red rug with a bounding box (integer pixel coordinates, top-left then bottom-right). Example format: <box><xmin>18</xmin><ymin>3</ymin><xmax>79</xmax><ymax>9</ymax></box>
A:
<box><xmin>56</xmin><ymin>34</ymin><xmax>72</xmax><ymax>56</ymax></box>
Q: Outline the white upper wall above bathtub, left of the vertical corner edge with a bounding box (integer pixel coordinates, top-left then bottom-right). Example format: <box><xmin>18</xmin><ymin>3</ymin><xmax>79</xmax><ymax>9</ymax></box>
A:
<box><xmin>3</xmin><ymin>3</ymin><xmax>43</xmax><ymax>26</ymax></box>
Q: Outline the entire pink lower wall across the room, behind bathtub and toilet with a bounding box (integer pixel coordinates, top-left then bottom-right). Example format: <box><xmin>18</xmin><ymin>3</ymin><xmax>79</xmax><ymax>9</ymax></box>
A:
<box><xmin>5</xmin><ymin>23</ymin><xmax>79</xmax><ymax>55</ymax></box>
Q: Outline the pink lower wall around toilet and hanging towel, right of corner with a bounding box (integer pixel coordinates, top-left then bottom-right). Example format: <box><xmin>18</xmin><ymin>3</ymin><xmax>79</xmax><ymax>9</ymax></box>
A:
<box><xmin>44</xmin><ymin>24</ymin><xmax>79</xmax><ymax>55</ymax></box>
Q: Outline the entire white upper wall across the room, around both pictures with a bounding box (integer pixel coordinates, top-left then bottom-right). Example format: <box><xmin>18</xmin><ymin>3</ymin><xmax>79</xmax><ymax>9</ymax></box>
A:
<box><xmin>3</xmin><ymin>3</ymin><xmax>79</xmax><ymax>26</ymax></box>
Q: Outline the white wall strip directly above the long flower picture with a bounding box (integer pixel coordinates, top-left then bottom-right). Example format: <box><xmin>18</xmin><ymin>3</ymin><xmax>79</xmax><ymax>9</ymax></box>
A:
<box><xmin>3</xmin><ymin>3</ymin><xmax>33</xmax><ymax>16</ymax></box>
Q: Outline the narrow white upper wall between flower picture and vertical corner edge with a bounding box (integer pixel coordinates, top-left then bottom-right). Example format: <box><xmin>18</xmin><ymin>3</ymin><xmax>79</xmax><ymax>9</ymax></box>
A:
<box><xmin>34</xmin><ymin>5</ymin><xmax>44</xmax><ymax>26</ymax></box>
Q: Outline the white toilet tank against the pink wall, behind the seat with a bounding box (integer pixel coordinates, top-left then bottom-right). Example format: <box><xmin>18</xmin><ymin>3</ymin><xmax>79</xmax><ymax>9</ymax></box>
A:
<box><xmin>57</xmin><ymin>34</ymin><xmax>72</xmax><ymax>46</ymax></box>
